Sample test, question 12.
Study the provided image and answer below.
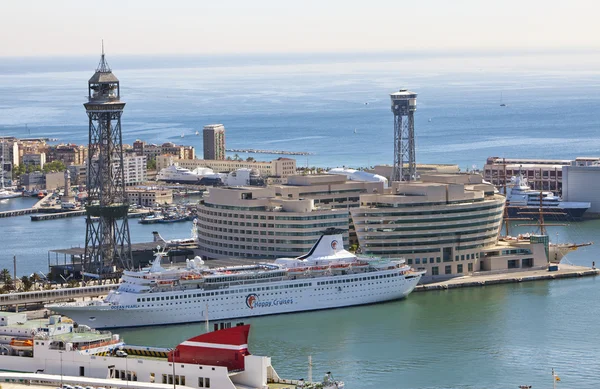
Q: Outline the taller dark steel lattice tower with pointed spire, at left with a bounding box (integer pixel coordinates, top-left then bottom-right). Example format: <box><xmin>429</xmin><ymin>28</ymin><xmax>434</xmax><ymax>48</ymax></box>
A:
<box><xmin>83</xmin><ymin>46</ymin><xmax>132</xmax><ymax>278</ymax></box>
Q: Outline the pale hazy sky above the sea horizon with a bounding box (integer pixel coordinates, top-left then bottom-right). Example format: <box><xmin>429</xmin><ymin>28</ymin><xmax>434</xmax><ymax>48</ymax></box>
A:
<box><xmin>0</xmin><ymin>0</ymin><xmax>600</xmax><ymax>56</ymax></box>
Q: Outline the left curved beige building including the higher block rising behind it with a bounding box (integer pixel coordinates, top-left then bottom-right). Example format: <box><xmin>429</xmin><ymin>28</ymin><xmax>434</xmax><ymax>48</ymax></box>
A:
<box><xmin>198</xmin><ymin>175</ymin><xmax>383</xmax><ymax>258</ymax></box>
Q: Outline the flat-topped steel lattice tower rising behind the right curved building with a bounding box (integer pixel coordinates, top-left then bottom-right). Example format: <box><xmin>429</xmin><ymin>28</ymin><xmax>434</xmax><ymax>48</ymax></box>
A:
<box><xmin>390</xmin><ymin>89</ymin><xmax>417</xmax><ymax>181</ymax></box>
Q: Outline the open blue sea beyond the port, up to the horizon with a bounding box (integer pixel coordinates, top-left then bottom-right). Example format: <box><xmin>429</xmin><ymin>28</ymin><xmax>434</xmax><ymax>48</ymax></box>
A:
<box><xmin>0</xmin><ymin>50</ymin><xmax>600</xmax><ymax>169</ymax></box>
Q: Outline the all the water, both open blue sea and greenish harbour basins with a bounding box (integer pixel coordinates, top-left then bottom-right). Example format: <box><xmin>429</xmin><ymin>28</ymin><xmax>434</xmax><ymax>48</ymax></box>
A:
<box><xmin>0</xmin><ymin>50</ymin><xmax>600</xmax><ymax>389</ymax></box>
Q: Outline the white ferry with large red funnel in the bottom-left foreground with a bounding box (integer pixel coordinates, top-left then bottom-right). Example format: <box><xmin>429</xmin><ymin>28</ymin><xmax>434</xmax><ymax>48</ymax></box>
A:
<box><xmin>0</xmin><ymin>312</ymin><xmax>344</xmax><ymax>389</ymax></box>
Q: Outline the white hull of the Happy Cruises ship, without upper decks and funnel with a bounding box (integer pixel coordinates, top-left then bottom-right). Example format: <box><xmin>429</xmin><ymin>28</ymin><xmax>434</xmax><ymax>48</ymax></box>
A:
<box><xmin>49</xmin><ymin>269</ymin><xmax>422</xmax><ymax>329</ymax></box>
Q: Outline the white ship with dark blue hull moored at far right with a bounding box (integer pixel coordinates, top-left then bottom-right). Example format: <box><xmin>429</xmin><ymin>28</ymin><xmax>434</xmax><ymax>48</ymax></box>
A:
<box><xmin>506</xmin><ymin>173</ymin><xmax>591</xmax><ymax>220</ymax></box>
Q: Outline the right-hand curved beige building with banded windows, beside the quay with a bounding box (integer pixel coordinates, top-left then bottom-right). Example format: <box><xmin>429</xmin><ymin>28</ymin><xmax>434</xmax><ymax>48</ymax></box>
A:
<box><xmin>350</xmin><ymin>174</ymin><xmax>547</xmax><ymax>282</ymax></box>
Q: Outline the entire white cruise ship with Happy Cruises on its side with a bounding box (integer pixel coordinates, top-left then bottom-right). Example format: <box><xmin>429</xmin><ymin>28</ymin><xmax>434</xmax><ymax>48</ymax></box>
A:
<box><xmin>46</xmin><ymin>228</ymin><xmax>424</xmax><ymax>328</ymax></box>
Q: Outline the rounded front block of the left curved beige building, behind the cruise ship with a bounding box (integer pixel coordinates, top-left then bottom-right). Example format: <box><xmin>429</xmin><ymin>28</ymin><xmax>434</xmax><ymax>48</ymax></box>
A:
<box><xmin>197</xmin><ymin>187</ymin><xmax>348</xmax><ymax>258</ymax></box>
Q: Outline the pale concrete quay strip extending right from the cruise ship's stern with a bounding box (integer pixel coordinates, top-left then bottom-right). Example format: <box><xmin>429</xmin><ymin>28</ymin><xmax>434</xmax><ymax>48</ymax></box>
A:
<box><xmin>414</xmin><ymin>264</ymin><xmax>600</xmax><ymax>292</ymax></box>
